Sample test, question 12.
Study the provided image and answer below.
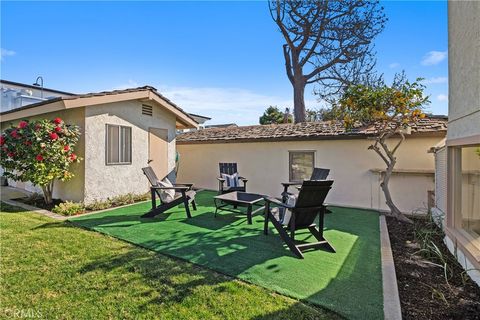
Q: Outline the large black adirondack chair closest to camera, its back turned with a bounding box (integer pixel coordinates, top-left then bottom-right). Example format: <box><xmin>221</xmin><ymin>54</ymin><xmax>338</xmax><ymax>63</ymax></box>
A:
<box><xmin>264</xmin><ymin>180</ymin><xmax>335</xmax><ymax>259</ymax></box>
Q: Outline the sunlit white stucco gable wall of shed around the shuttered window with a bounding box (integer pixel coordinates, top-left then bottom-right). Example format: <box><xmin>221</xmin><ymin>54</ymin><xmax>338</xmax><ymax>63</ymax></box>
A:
<box><xmin>84</xmin><ymin>101</ymin><xmax>175</xmax><ymax>203</ymax></box>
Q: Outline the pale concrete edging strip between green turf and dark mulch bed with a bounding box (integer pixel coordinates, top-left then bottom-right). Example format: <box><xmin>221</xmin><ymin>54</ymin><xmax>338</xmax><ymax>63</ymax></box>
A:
<box><xmin>379</xmin><ymin>215</ymin><xmax>402</xmax><ymax>320</ymax></box>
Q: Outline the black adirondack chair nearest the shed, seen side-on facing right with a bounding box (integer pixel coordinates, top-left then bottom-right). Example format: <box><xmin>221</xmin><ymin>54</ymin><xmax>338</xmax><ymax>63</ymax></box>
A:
<box><xmin>142</xmin><ymin>166</ymin><xmax>197</xmax><ymax>218</ymax></box>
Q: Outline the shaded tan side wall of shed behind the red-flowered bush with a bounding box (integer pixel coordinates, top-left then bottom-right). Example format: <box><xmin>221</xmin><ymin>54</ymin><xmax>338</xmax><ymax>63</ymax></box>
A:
<box><xmin>1</xmin><ymin>108</ymin><xmax>85</xmax><ymax>201</ymax></box>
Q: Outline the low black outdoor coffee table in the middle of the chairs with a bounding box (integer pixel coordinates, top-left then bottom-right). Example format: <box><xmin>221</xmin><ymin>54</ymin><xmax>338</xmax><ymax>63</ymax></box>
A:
<box><xmin>213</xmin><ymin>191</ymin><xmax>265</xmax><ymax>224</ymax></box>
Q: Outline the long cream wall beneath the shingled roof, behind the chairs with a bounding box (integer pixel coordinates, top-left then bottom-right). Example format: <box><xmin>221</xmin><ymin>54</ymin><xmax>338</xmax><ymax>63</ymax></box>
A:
<box><xmin>177</xmin><ymin>137</ymin><xmax>442</xmax><ymax>212</ymax></box>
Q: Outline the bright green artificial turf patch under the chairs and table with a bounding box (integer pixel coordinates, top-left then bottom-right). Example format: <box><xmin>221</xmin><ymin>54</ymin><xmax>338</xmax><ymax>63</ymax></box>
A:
<box><xmin>70</xmin><ymin>191</ymin><xmax>383</xmax><ymax>319</ymax></box>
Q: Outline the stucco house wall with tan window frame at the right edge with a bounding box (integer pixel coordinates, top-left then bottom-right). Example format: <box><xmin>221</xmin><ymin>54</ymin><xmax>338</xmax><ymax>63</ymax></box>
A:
<box><xmin>437</xmin><ymin>1</ymin><xmax>480</xmax><ymax>285</ymax></box>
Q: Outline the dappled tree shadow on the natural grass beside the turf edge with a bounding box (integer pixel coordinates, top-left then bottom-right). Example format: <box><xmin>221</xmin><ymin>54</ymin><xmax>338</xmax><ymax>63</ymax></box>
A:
<box><xmin>79</xmin><ymin>240</ymin><xmax>340</xmax><ymax>320</ymax></box>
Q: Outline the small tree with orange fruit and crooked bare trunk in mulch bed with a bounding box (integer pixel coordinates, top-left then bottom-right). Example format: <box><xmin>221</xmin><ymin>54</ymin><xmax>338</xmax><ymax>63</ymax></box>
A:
<box><xmin>334</xmin><ymin>77</ymin><xmax>429</xmax><ymax>222</ymax></box>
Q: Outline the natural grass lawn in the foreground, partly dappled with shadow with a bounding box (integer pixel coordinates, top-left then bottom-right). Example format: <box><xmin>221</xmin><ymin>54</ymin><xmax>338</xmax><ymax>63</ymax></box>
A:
<box><xmin>0</xmin><ymin>204</ymin><xmax>339</xmax><ymax>319</ymax></box>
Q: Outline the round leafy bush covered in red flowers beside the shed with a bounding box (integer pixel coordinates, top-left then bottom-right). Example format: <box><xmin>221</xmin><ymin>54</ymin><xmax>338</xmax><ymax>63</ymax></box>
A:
<box><xmin>0</xmin><ymin>118</ymin><xmax>81</xmax><ymax>204</ymax></box>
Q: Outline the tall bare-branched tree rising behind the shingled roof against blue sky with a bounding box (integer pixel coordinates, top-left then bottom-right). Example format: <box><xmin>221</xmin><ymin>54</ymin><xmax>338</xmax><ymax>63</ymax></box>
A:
<box><xmin>269</xmin><ymin>0</ymin><xmax>386</xmax><ymax>122</ymax></box>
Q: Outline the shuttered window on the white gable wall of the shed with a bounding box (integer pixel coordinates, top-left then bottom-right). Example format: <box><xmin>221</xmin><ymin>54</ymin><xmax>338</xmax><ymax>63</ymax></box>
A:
<box><xmin>105</xmin><ymin>124</ymin><xmax>132</xmax><ymax>165</ymax></box>
